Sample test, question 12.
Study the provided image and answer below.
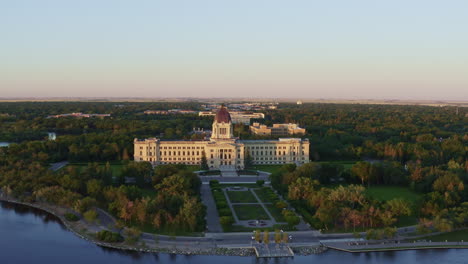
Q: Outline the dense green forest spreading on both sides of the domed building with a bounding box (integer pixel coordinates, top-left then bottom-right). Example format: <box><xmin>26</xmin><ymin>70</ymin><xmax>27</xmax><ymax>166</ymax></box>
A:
<box><xmin>0</xmin><ymin>102</ymin><xmax>468</xmax><ymax>236</ymax></box>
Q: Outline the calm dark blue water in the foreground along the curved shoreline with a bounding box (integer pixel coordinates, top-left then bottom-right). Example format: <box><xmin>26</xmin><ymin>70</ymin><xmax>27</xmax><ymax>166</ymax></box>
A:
<box><xmin>0</xmin><ymin>202</ymin><xmax>468</xmax><ymax>264</ymax></box>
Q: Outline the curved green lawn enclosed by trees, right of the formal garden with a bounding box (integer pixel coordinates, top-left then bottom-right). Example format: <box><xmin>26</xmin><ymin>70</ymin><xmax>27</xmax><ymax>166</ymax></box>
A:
<box><xmin>366</xmin><ymin>186</ymin><xmax>421</xmax><ymax>205</ymax></box>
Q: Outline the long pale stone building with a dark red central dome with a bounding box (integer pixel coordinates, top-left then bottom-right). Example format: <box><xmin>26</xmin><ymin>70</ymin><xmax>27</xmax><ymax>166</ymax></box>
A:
<box><xmin>134</xmin><ymin>107</ymin><xmax>309</xmax><ymax>169</ymax></box>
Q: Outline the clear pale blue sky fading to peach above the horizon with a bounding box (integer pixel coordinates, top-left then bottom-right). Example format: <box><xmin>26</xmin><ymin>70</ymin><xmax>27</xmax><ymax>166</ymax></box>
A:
<box><xmin>0</xmin><ymin>0</ymin><xmax>468</xmax><ymax>100</ymax></box>
